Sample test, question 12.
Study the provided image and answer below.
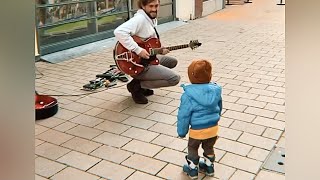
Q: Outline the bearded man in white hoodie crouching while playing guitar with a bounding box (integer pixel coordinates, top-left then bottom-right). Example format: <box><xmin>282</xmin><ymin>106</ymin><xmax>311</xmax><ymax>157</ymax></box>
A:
<box><xmin>114</xmin><ymin>0</ymin><xmax>180</xmax><ymax>104</ymax></box>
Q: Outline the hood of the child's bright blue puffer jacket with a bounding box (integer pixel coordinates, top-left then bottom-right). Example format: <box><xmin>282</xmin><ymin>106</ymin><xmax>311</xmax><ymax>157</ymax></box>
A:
<box><xmin>182</xmin><ymin>83</ymin><xmax>221</xmax><ymax>106</ymax></box>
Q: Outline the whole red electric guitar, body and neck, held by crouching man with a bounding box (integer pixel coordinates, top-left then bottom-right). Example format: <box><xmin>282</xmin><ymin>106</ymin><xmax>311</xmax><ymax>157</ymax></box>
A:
<box><xmin>114</xmin><ymin>36</ymin><xmax>201</xmax><ymax>76</ymax></box>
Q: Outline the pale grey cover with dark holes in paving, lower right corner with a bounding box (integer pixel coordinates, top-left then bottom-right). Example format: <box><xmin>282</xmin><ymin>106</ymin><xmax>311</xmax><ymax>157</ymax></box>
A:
<box><xmin>262</xmin><ymin>147</ymin><xmax>286</xmax><ymax>174</ymax></box>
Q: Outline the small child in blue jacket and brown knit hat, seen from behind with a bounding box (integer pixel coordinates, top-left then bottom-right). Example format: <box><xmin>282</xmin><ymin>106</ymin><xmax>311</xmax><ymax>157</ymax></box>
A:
<box><xmin>177</xmin><ymin>60</ymin><xmax>222</xmax><ymax>179</ymax></box>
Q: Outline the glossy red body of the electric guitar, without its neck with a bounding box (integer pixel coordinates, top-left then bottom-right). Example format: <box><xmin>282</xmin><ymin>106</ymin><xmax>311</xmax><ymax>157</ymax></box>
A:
<box><xmin>114</xmin><ymin>36</ymin><xmax>161</xmax><ymax>76</ymax></box>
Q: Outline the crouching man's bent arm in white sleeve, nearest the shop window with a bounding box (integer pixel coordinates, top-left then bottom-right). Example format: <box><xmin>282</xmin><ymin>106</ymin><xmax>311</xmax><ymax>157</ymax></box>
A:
<box><xmin>114</xmin><ymin>17</ymin><xmax>143</xmax><ymax>54</ymax></box>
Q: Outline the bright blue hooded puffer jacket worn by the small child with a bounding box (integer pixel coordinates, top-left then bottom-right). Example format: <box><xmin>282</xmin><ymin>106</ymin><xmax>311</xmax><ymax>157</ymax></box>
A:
<box><xmin>177</xmin><ymin>83</ymin><xmax>222</xmax><ymax>137</ymax></box>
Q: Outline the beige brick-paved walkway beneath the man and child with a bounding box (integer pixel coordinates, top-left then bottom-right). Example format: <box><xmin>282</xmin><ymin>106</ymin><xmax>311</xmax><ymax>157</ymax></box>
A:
<box><xmin>35</xmin><ymin>0</ymin><xmax>285</xmax><ymax>180</ymax></box>
